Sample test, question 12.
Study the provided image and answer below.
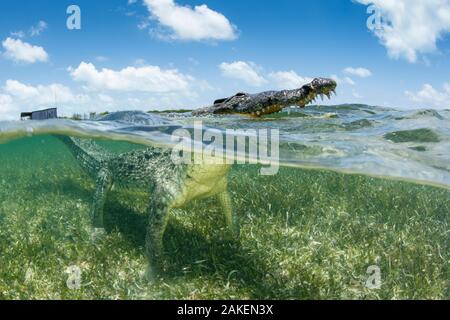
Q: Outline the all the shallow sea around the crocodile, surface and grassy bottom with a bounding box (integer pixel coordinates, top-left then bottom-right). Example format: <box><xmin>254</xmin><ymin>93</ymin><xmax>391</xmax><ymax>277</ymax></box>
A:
<box><xmin>0</xmin><ymin>105</ymin><xmax>450</xmax><ymax>299</ymax></box>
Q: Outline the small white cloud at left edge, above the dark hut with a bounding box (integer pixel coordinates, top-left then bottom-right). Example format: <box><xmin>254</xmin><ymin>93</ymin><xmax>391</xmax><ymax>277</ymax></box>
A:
<box><xmin>2</xmin><ymin>38</ymin><xmax>48</xmax><ymax>63</ymax></box>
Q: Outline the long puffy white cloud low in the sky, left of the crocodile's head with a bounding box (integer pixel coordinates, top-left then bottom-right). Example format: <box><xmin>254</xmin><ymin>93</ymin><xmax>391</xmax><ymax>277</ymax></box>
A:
<box><xmin>69</xmin><ymin>62</ymin><xmax>195</xmax><ymax>93</ymax></box>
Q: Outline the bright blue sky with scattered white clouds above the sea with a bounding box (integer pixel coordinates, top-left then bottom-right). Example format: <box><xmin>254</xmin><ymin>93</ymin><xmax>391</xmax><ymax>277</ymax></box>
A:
<box><xmin>0</xmin><ymin>0</ymin><xmax>450</xmax><ymax>120</ymax></box>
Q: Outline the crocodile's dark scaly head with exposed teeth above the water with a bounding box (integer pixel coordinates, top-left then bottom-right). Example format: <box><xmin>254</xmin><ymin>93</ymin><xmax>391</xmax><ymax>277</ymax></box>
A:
<box><xmin>193</xmin><ymin>78</ymin><xmax>337</xmax><ymax>117</ymax></box>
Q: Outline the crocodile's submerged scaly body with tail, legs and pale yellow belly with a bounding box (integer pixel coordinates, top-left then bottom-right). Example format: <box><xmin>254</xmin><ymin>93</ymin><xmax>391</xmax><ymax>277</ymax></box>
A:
<box><xmin>57</xmin><ymin>136</ymin><xmax>239</xmax><ymax>279</ymax></box>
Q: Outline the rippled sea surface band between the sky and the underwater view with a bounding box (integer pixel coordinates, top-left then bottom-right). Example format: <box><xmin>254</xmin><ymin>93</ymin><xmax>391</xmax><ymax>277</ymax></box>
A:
<box><xmin>0</xmin><ymin>105</ymin><xmax>450</xmax><ymax>188</ymax></box>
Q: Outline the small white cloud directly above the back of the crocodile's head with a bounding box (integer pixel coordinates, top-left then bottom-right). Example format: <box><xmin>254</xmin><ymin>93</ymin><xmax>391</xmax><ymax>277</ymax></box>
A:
<box><xmin>219</xmin><ymin>61</ymin><xmax>267</xmax><ymax>87</ymax></box>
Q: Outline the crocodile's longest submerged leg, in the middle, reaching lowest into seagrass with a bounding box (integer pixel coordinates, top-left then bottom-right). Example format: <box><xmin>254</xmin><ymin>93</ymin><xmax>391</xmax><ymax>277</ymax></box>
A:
<box><xmin>145</xmin><ymin>190</ymin><xmax>171</xmax><ymax>280</ymax></box>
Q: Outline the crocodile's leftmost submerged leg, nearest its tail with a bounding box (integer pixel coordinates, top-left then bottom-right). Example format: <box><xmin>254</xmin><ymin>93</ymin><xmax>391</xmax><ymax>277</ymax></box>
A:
<box><xmin>91</xmin><ymin>169</ymin><xmax>112</xmax><ymax>229</ymax></box>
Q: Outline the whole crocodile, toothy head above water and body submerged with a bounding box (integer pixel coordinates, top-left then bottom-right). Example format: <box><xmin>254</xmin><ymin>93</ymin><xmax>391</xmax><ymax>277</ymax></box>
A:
<box><xmin>51</xmin><ymin>78</ymin><xmax>336</xmax><ymax>279</ymax></box>
